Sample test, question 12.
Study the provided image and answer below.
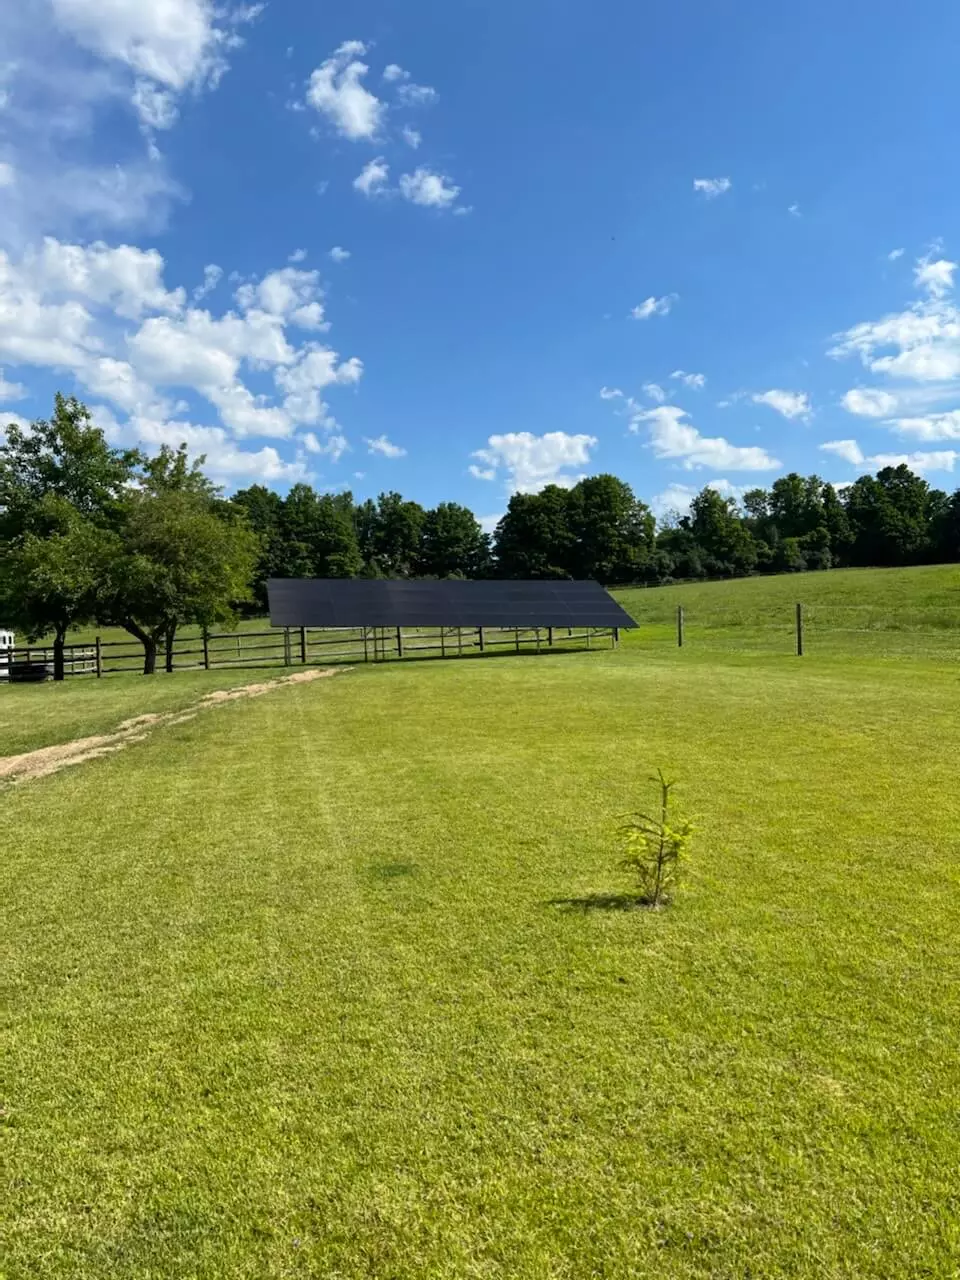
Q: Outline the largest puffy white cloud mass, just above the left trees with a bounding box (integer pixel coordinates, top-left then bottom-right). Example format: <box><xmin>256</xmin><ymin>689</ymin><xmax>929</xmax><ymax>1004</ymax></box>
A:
<box><xmin>0</xmin><ymin>238</ymin><xmax>362</xmax><ymax>477</ymax></box>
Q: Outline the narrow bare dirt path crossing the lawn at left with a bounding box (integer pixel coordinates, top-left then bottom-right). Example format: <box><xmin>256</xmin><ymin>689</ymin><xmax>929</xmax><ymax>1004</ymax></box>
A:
<box><xmin>0</xmin><ymin>667</ymin><xmax>343</xmax><ymax>785</ymax></box>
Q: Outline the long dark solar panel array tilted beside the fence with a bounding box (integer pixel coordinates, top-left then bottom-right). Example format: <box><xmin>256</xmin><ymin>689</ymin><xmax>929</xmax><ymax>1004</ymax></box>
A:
<box><xmin>266</xmin><ymin>577</ymin><xmax>636</xmax><ymax>628</ymax></box>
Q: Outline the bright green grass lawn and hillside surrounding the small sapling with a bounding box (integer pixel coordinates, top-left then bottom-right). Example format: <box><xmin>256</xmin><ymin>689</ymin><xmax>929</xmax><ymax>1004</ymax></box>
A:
<box><xmin>0</xmin><ymin>570</ymin><xmax>960</xmax><ymax>1280</ymax></box>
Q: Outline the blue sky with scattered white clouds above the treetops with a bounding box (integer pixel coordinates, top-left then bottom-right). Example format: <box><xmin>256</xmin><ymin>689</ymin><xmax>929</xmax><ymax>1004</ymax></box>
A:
<box><xmin>0</xmin><ymin>0</ymin><xmax>960</xmax><ymax>522</ymax></box>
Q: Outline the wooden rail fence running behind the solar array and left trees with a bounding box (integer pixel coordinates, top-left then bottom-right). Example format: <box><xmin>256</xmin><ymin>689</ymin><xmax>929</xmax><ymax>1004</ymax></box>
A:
<box><xmin>0</xmin><ymin>627</ymin><xmax>620</xmax><ymax>681</ymax></box>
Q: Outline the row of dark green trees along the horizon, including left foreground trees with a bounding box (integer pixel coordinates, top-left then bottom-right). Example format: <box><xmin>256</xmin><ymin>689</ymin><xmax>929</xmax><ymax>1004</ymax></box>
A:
<box><xmin>0</xmin><ymin>396</ymin><xmax>960</xmax><ymax>678</ymax></box>
